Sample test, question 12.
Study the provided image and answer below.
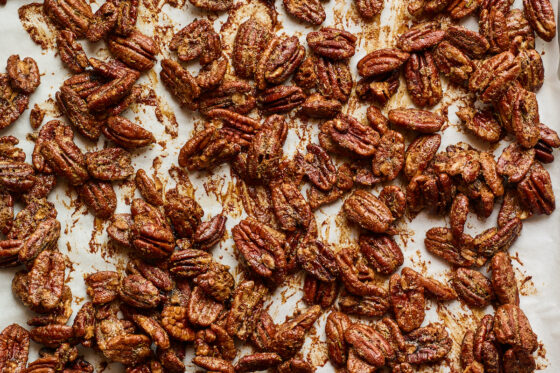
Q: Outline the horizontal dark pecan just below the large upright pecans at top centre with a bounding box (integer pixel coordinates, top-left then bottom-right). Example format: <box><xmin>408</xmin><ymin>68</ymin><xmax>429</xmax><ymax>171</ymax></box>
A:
<box><xmin>257</xmin><ymin>85</ymin><xmax>305</xmax><ymax>115</ymax></box>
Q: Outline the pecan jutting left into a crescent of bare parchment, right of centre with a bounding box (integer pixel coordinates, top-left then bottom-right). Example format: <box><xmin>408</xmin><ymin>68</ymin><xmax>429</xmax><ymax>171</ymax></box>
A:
<box><xmin>424</xmin><ymin>227</ymin><xmax>480</xmax><ymax>267</ymax></box>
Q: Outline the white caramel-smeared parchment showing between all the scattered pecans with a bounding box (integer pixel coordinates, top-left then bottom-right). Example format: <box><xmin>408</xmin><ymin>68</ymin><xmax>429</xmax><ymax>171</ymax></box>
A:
<box><xmin>0</xmin><ymin>0</ymin><xmax>560</xmax><ymax>372</ymax></box>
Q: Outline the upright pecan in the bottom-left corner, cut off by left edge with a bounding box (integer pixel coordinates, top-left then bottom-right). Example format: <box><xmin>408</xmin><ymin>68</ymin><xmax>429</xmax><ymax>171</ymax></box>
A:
<box><xmin>0</xmin><ymin>324</ymin><xmax>29</xmax><ymax>373</ymax></box>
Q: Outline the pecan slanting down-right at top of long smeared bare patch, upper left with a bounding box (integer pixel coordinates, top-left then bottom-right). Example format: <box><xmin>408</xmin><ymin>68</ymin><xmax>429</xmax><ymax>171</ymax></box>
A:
<box><xmin>160</xmin><ymin>59</ymin><xmax>200</xmax><ymax>110</ymax></box>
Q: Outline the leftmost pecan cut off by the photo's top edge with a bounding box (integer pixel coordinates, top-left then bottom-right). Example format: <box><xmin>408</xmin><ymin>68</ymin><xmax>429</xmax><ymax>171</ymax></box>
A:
<box><xmin>43</xmin><ymin>0</ymin><xmax>93</xmax><ymax>38</ymax></box>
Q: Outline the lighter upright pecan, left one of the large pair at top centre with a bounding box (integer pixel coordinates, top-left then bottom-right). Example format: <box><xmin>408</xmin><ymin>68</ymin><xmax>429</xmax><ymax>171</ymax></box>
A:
<box><xmin>232</xmin><ymin>17</ymin><xmax>270</xmax><ymax>78</ymax></box>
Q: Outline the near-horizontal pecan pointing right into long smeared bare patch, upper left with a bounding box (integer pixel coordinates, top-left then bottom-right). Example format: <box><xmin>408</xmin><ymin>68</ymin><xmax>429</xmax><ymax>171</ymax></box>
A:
<box><xmin>102</xmin><ymin>116</ymin><xmax>156</xmax><ymax>149</ymax></box>
